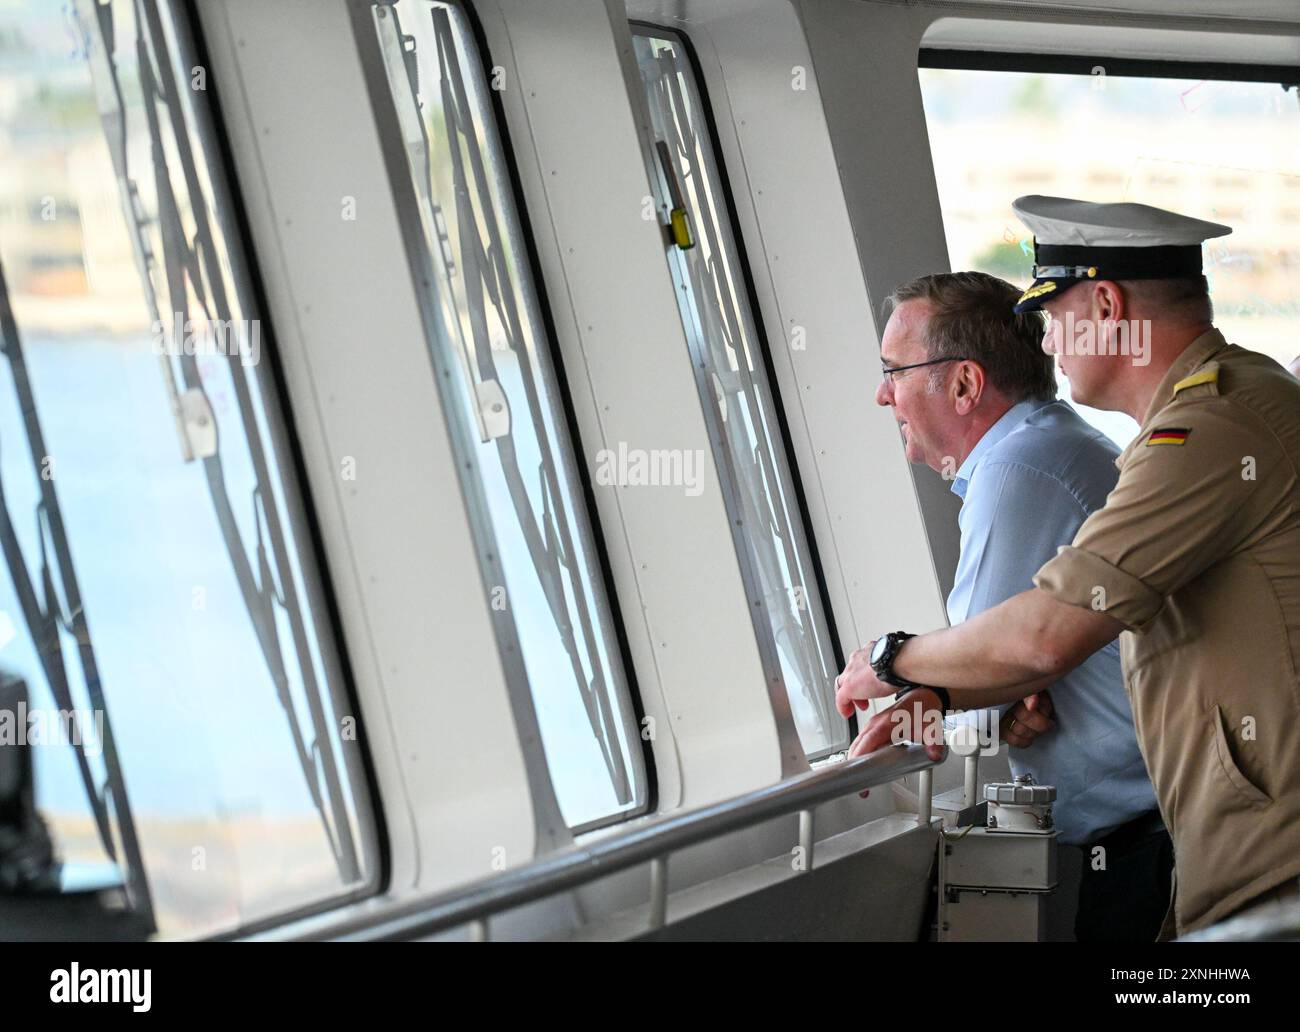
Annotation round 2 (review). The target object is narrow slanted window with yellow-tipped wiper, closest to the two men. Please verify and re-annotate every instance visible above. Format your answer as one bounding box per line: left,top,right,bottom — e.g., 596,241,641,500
632,25,849,759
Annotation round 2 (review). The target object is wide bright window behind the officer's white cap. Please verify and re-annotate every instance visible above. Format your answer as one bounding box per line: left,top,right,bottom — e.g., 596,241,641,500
920,60,1300,445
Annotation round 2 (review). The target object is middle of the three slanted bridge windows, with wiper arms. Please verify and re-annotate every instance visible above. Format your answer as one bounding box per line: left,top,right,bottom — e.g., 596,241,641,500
369,0,647,831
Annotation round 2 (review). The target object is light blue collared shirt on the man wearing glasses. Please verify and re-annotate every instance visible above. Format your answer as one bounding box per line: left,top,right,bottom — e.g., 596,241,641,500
948,400,1156,845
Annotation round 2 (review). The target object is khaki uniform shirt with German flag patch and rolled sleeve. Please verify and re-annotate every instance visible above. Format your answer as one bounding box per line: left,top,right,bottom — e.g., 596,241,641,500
1035,330,1300,933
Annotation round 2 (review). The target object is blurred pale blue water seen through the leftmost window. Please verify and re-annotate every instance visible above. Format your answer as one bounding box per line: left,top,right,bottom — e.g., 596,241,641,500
0,327,340,842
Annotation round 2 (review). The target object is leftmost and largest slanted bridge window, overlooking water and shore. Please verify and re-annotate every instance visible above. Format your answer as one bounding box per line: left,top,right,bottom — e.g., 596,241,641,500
0,0,378,938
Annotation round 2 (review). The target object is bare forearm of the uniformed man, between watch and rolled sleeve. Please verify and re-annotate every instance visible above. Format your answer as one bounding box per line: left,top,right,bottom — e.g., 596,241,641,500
894,587,1123,710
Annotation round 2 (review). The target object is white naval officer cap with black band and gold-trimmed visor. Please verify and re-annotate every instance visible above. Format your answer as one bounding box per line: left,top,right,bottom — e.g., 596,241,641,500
1011,194,1232,312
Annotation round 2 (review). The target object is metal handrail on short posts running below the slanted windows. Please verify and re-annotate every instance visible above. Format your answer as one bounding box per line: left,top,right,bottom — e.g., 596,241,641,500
270,743,935,941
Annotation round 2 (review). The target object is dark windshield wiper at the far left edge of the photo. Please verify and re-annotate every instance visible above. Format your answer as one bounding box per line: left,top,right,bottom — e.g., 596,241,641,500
0,253,155,928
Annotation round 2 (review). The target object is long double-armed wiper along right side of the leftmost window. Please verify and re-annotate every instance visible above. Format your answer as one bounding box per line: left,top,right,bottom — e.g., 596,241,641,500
77,0,360,883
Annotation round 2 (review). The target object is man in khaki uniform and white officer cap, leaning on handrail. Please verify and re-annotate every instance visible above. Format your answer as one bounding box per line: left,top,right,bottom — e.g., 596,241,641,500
837,198,1300,935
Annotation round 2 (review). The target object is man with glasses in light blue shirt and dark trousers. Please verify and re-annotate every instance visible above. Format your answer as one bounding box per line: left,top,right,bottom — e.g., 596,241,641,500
876,273,1173,941
